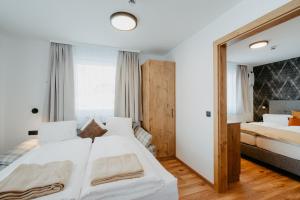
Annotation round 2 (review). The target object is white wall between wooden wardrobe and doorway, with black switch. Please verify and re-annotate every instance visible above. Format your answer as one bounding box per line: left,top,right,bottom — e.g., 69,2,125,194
168,0,288,182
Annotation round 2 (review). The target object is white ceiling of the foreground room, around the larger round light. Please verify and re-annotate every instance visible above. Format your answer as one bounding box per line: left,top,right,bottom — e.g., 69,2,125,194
0,0,241,54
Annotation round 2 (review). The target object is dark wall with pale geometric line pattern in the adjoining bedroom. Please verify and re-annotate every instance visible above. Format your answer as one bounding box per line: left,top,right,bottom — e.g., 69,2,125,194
253,57,300,121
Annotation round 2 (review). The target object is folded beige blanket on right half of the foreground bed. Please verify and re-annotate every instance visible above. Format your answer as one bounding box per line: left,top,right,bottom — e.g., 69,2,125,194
91,154,144,186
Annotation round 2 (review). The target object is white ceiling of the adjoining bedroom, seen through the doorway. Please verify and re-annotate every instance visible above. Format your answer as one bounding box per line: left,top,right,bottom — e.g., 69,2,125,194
227,17,300,66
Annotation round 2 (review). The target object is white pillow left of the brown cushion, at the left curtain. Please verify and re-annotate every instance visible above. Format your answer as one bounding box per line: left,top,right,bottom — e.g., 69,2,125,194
38,121,77,144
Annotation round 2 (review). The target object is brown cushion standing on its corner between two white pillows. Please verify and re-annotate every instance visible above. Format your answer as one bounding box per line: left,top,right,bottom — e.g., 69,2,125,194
79,120,107,142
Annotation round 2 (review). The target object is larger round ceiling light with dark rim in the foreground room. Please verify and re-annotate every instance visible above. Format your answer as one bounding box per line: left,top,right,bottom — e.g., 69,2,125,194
110,12,137,31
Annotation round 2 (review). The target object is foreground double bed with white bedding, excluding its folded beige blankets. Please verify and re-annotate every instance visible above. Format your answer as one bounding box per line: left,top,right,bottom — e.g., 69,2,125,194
0,118,178,200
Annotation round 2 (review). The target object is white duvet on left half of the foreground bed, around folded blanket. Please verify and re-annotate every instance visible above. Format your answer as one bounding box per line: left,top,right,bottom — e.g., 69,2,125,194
0,138,91,200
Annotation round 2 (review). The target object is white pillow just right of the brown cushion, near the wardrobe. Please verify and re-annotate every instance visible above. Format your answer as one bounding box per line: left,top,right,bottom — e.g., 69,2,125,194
106,117,134,137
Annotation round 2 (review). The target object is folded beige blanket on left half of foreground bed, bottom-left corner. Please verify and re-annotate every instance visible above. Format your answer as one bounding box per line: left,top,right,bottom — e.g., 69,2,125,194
0,161,73,200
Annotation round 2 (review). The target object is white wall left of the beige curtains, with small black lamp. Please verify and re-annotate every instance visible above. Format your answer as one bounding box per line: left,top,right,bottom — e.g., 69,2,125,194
0,32,49,152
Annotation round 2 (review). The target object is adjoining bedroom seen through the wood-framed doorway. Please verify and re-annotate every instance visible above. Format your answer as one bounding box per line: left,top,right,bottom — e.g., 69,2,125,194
227,13,300,194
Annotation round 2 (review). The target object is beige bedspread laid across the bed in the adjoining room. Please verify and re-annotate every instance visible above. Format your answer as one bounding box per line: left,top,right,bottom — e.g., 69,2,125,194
241,123,300,145
